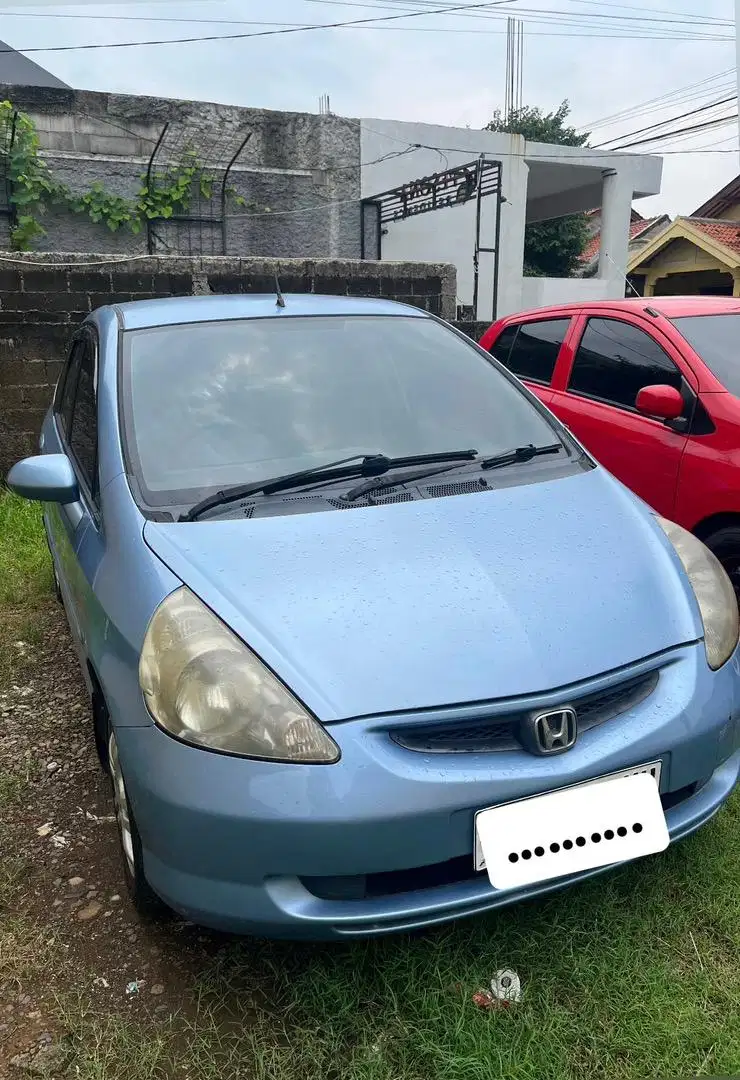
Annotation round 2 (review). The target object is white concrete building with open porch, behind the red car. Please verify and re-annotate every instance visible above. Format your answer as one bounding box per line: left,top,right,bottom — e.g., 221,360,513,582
360,120,661,321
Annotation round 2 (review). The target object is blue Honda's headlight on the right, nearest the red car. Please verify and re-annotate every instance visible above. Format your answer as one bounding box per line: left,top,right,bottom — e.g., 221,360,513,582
657,517,740,671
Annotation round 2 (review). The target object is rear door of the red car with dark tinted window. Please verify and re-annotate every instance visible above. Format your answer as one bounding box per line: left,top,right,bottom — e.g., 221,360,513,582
488,315,570,405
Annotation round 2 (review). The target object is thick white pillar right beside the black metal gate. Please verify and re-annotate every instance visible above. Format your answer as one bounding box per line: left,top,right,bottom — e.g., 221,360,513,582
492,135,529,319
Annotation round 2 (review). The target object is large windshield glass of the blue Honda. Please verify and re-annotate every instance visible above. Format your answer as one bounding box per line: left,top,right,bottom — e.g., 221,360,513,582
123,315,554,505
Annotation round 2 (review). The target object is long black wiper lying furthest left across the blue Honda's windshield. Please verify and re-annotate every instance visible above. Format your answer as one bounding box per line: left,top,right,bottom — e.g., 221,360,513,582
179,450,477,522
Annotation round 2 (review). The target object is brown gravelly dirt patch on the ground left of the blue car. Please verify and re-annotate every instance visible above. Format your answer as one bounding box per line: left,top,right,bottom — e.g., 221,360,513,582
0,604,231,1077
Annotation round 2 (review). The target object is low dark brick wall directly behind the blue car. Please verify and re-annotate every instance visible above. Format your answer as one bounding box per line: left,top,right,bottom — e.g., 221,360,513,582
0,255,456,477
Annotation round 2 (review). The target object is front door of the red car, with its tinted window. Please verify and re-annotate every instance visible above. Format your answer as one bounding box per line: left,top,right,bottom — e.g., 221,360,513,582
550,313,697,516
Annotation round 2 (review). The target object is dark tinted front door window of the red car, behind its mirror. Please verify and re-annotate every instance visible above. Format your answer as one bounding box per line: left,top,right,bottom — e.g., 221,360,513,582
568,319,683,408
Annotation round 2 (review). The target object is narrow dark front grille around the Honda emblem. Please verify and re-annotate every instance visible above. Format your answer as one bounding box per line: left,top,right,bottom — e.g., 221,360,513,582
391,672,659,754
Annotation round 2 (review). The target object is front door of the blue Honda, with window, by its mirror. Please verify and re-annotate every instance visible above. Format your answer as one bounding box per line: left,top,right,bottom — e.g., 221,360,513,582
45,327,103,663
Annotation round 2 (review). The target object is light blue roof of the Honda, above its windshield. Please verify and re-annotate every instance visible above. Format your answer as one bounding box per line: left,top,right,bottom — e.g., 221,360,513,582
105,293,429,330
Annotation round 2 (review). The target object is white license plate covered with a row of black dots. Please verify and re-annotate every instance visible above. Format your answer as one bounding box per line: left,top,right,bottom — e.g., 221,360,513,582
475,761,670,889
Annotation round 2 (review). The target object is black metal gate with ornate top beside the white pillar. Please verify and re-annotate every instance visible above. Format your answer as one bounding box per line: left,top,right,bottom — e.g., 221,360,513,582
360,153,504,319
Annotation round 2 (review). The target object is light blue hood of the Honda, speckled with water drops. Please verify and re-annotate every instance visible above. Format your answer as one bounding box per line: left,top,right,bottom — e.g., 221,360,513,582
145,469,702,721
